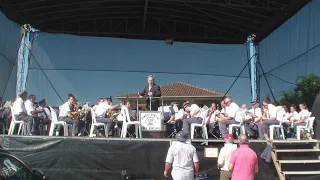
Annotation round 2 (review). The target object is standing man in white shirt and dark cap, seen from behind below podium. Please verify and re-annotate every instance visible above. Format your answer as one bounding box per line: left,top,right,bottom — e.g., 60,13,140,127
163,131,199,180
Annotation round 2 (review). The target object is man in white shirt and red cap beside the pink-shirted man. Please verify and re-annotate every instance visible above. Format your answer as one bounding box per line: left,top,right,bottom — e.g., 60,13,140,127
218,134,238,180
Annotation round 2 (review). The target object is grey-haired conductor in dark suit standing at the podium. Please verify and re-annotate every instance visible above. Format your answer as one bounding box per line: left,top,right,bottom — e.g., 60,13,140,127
139,75,161,111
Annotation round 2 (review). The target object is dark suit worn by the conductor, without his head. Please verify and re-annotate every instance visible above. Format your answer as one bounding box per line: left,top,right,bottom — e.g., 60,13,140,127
140,84,161,111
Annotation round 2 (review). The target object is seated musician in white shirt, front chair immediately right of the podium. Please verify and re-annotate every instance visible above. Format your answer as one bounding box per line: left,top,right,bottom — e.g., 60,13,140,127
183,102,203,134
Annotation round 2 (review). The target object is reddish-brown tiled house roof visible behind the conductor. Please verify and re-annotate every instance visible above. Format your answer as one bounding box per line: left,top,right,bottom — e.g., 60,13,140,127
117,82,224,98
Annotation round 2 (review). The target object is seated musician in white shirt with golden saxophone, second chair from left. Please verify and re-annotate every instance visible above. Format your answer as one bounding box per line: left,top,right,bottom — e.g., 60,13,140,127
58,94,79,136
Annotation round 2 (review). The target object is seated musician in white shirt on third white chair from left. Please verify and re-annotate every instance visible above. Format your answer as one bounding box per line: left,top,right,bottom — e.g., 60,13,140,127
95,97,120,136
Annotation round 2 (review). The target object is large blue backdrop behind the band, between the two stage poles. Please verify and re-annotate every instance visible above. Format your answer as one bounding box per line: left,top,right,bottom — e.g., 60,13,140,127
27,33,251,104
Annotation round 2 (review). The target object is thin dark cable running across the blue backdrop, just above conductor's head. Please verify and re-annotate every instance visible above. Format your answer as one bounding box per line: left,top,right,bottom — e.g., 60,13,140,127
29,68,249,78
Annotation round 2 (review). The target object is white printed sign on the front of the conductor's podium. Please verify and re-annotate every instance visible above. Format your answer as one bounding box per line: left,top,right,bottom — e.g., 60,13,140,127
139,111,163,131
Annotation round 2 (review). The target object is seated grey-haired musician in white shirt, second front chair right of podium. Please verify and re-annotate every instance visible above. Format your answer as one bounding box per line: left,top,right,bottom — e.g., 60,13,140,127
218,97,240,138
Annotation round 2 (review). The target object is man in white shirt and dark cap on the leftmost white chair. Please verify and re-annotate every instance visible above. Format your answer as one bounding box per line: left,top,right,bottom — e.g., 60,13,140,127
12,91,33,135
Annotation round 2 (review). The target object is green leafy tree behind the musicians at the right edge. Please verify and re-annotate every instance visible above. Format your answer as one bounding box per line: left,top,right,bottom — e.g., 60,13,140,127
280,74,320,110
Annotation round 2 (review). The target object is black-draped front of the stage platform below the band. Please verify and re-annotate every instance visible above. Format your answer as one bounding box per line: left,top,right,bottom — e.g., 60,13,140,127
0,135,319,180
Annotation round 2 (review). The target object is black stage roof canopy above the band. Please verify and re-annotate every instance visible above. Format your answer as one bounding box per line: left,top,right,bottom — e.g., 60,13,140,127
0,0,311,44
